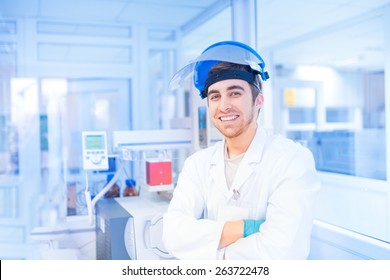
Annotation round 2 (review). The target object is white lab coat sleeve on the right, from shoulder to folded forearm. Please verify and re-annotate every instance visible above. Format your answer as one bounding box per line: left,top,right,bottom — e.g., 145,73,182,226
225,145,320,260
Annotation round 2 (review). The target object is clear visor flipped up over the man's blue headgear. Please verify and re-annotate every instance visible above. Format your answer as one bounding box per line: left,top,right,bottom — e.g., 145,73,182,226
169,44,265,90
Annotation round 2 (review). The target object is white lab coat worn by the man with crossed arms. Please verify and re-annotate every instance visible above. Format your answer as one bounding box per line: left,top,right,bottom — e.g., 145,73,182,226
163,127,320,260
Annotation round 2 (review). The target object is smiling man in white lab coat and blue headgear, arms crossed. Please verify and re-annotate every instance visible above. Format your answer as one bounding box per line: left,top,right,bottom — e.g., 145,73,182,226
163,41,319,259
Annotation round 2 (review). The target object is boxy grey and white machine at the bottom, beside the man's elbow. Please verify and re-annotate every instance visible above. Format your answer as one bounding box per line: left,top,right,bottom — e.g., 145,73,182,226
96,192,173,260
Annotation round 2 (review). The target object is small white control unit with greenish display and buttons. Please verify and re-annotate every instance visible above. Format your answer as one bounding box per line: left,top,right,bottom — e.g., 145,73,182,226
82,131,108,170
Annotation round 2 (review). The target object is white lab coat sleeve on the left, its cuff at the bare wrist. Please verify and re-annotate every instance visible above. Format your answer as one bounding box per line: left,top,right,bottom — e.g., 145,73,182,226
162,154,224,260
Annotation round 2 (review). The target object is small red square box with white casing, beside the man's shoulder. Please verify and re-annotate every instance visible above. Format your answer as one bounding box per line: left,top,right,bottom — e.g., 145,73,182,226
146,160,172,186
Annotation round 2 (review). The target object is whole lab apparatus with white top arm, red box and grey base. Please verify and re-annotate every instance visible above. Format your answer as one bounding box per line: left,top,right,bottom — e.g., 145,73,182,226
85,129,192,259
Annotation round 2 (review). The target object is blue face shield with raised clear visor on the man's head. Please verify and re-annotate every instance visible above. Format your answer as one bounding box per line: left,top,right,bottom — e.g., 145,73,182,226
169,41,269,98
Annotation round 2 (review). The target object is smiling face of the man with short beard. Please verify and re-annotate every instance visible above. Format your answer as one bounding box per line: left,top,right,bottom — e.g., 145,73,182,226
207,79,263,138
